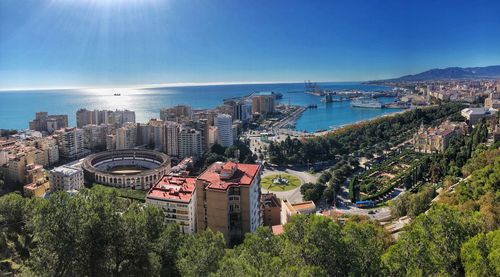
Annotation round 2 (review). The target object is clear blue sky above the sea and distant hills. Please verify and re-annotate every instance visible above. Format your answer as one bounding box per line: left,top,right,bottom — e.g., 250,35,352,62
0,0,500,88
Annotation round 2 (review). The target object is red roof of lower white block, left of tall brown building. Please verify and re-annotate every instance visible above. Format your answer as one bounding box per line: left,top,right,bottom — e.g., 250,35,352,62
146,175,196,202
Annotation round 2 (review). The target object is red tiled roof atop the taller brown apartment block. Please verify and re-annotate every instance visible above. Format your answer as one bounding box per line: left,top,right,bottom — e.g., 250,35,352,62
198,162,260,190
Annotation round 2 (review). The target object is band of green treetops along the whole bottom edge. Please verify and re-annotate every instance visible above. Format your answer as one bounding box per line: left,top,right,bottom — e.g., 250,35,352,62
0,182,499,276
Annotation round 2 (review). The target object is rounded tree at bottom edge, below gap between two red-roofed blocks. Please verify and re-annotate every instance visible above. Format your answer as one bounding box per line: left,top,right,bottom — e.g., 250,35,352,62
177,227,226,277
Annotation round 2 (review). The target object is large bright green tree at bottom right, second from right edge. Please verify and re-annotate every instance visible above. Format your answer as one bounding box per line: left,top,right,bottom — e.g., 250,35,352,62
382,206,482,276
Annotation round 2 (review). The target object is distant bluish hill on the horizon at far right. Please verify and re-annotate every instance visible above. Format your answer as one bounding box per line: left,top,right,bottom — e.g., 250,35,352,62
374,65,500,81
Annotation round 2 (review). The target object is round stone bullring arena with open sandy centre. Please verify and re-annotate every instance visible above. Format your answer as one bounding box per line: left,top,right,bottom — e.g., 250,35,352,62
82,149,170,190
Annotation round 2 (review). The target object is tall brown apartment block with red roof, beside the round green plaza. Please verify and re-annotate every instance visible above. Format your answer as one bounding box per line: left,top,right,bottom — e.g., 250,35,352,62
195,162,262,245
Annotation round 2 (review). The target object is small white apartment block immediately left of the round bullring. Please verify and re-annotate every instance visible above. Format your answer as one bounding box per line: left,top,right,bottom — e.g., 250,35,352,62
49,165,83,191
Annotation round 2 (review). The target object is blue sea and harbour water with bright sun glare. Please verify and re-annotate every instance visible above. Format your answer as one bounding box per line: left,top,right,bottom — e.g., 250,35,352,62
0,83,396,131
